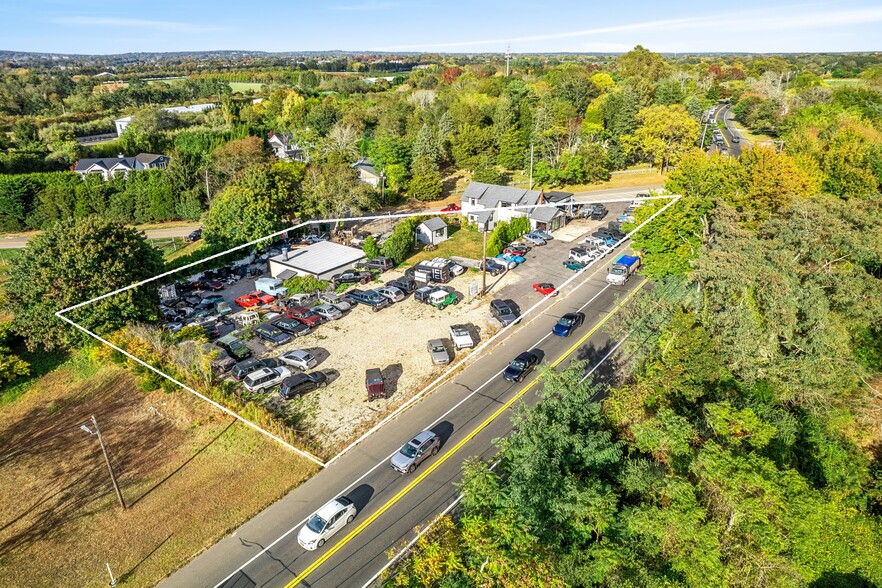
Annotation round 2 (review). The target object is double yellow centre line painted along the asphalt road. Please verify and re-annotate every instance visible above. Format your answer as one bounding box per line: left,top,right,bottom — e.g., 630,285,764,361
285,279,646,588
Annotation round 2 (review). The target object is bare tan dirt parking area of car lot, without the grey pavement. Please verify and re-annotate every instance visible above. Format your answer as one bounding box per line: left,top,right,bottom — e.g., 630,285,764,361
237,269,521,455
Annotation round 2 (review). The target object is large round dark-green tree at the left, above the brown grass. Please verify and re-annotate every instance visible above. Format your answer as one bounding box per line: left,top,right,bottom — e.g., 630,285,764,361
6,216,163,350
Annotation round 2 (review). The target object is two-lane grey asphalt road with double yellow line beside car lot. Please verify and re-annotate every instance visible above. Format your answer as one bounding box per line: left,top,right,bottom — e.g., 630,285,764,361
162,248,643,588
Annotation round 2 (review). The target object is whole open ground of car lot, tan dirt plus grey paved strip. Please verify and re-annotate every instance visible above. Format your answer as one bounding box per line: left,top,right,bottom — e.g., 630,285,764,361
158,203,626,454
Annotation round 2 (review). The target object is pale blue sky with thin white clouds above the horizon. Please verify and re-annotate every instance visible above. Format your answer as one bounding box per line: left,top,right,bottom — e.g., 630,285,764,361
0,0,882,54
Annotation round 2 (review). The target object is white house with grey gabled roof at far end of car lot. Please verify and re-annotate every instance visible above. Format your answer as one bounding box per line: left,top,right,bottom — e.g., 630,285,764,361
460,182,573,231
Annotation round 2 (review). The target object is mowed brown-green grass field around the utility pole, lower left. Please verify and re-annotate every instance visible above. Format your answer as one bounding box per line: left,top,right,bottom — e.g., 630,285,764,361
0,364,315,588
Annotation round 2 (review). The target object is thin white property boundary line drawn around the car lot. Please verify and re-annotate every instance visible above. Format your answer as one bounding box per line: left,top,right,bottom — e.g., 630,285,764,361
55,195,682,468
